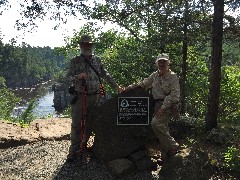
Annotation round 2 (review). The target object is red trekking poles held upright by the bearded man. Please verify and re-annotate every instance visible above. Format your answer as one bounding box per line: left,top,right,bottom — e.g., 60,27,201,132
80,79,87,162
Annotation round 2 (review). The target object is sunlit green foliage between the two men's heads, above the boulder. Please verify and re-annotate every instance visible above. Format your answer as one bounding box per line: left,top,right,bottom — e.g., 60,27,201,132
99,30,156,89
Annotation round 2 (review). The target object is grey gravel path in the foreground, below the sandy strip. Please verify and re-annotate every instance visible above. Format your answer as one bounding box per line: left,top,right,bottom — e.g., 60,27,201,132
0,140,159,180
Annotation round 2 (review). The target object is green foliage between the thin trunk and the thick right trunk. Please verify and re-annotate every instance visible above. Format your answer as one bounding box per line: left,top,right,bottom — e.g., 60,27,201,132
186,47,209,118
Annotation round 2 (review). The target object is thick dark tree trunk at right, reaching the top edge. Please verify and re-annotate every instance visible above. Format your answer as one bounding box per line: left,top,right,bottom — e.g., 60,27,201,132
205,0,224,131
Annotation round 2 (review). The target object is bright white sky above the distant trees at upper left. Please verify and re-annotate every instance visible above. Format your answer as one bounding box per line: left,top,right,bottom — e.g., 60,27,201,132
0,0,116,48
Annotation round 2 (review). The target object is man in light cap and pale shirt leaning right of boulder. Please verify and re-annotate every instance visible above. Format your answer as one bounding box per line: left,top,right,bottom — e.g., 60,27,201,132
125,53,180,163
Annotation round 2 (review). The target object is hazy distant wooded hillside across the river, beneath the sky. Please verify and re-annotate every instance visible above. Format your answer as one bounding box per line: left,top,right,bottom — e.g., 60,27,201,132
0,39,66,88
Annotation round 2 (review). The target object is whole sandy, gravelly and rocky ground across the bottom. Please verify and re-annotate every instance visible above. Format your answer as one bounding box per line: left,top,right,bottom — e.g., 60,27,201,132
0,118,240,180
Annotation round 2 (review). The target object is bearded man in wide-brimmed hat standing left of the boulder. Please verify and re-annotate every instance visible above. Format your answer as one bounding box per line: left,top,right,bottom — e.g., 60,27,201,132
66,35,122,162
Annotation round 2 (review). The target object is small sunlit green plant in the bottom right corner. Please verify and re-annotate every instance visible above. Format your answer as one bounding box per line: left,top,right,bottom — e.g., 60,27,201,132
224,146,240,171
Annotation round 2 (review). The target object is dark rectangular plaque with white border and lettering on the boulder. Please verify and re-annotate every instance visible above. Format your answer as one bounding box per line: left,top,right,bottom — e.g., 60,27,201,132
117,97,149,125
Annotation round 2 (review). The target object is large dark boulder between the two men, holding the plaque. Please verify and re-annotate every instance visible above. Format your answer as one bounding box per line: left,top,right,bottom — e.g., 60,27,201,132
93,88,156,162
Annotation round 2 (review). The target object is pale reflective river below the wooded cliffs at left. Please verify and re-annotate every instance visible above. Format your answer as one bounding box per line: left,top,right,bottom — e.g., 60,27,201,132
13,81,58,118
